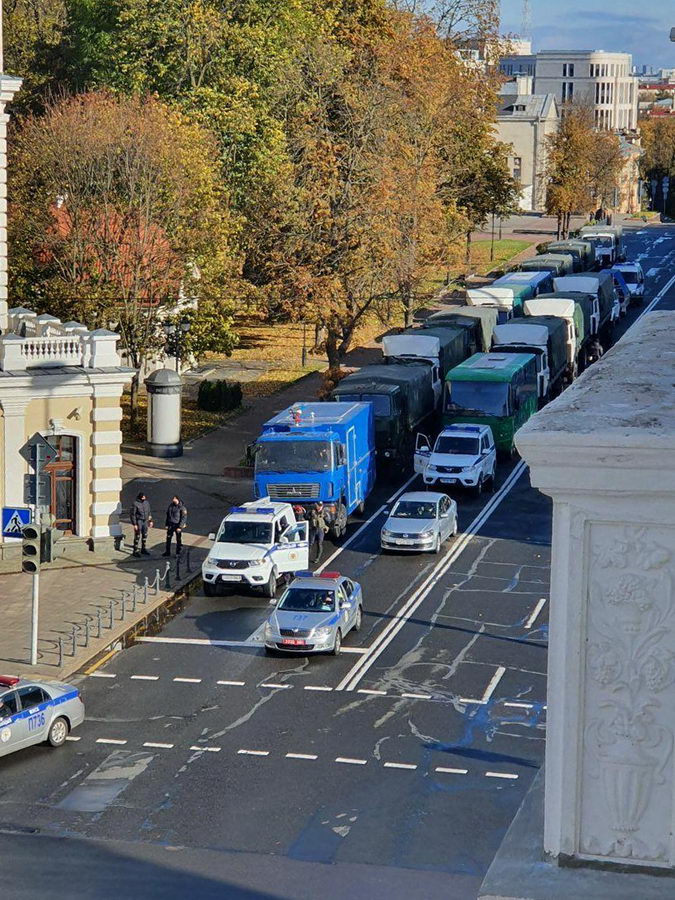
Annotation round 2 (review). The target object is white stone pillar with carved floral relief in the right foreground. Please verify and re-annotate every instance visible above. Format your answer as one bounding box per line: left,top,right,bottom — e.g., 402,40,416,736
516,312,675,872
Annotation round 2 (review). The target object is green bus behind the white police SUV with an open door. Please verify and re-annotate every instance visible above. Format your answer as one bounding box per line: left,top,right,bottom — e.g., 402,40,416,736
443,354,538,456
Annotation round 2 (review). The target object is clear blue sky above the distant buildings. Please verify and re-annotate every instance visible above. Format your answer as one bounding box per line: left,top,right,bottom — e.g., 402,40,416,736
501,0,675,68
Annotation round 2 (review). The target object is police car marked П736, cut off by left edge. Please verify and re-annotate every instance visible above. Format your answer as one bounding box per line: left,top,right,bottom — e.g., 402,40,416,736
0,675,84,756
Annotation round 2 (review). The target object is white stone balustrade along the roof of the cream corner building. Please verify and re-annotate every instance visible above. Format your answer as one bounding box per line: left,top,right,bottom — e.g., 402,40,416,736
0,307,122,372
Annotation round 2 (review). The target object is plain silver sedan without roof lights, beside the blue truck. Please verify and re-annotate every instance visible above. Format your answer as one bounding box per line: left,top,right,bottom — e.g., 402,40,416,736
380,491,457,553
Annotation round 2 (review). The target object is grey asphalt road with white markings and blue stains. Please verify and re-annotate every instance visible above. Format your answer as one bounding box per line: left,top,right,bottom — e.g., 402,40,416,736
0,226,675,900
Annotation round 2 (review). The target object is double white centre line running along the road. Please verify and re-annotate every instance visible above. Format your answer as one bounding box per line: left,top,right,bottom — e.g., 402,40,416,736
336,460,528,691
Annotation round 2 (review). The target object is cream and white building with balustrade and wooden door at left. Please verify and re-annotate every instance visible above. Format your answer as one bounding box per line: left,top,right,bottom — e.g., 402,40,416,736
0,54,133,569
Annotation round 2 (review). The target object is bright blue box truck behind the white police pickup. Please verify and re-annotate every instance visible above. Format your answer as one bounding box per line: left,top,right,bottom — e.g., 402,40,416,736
254,400,378,539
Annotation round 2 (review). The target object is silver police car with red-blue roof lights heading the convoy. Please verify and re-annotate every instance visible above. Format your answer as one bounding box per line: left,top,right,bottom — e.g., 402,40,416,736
264,572,363,656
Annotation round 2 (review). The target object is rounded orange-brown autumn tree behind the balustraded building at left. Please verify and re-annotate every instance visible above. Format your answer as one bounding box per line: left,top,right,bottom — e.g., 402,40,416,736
9,92,236,420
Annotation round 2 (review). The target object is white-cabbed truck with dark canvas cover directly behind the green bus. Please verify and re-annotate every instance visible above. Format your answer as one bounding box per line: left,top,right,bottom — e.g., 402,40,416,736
492,316,567,406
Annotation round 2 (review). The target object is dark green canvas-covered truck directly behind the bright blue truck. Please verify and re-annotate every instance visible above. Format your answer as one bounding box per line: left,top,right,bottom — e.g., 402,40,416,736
332,362,437,475
